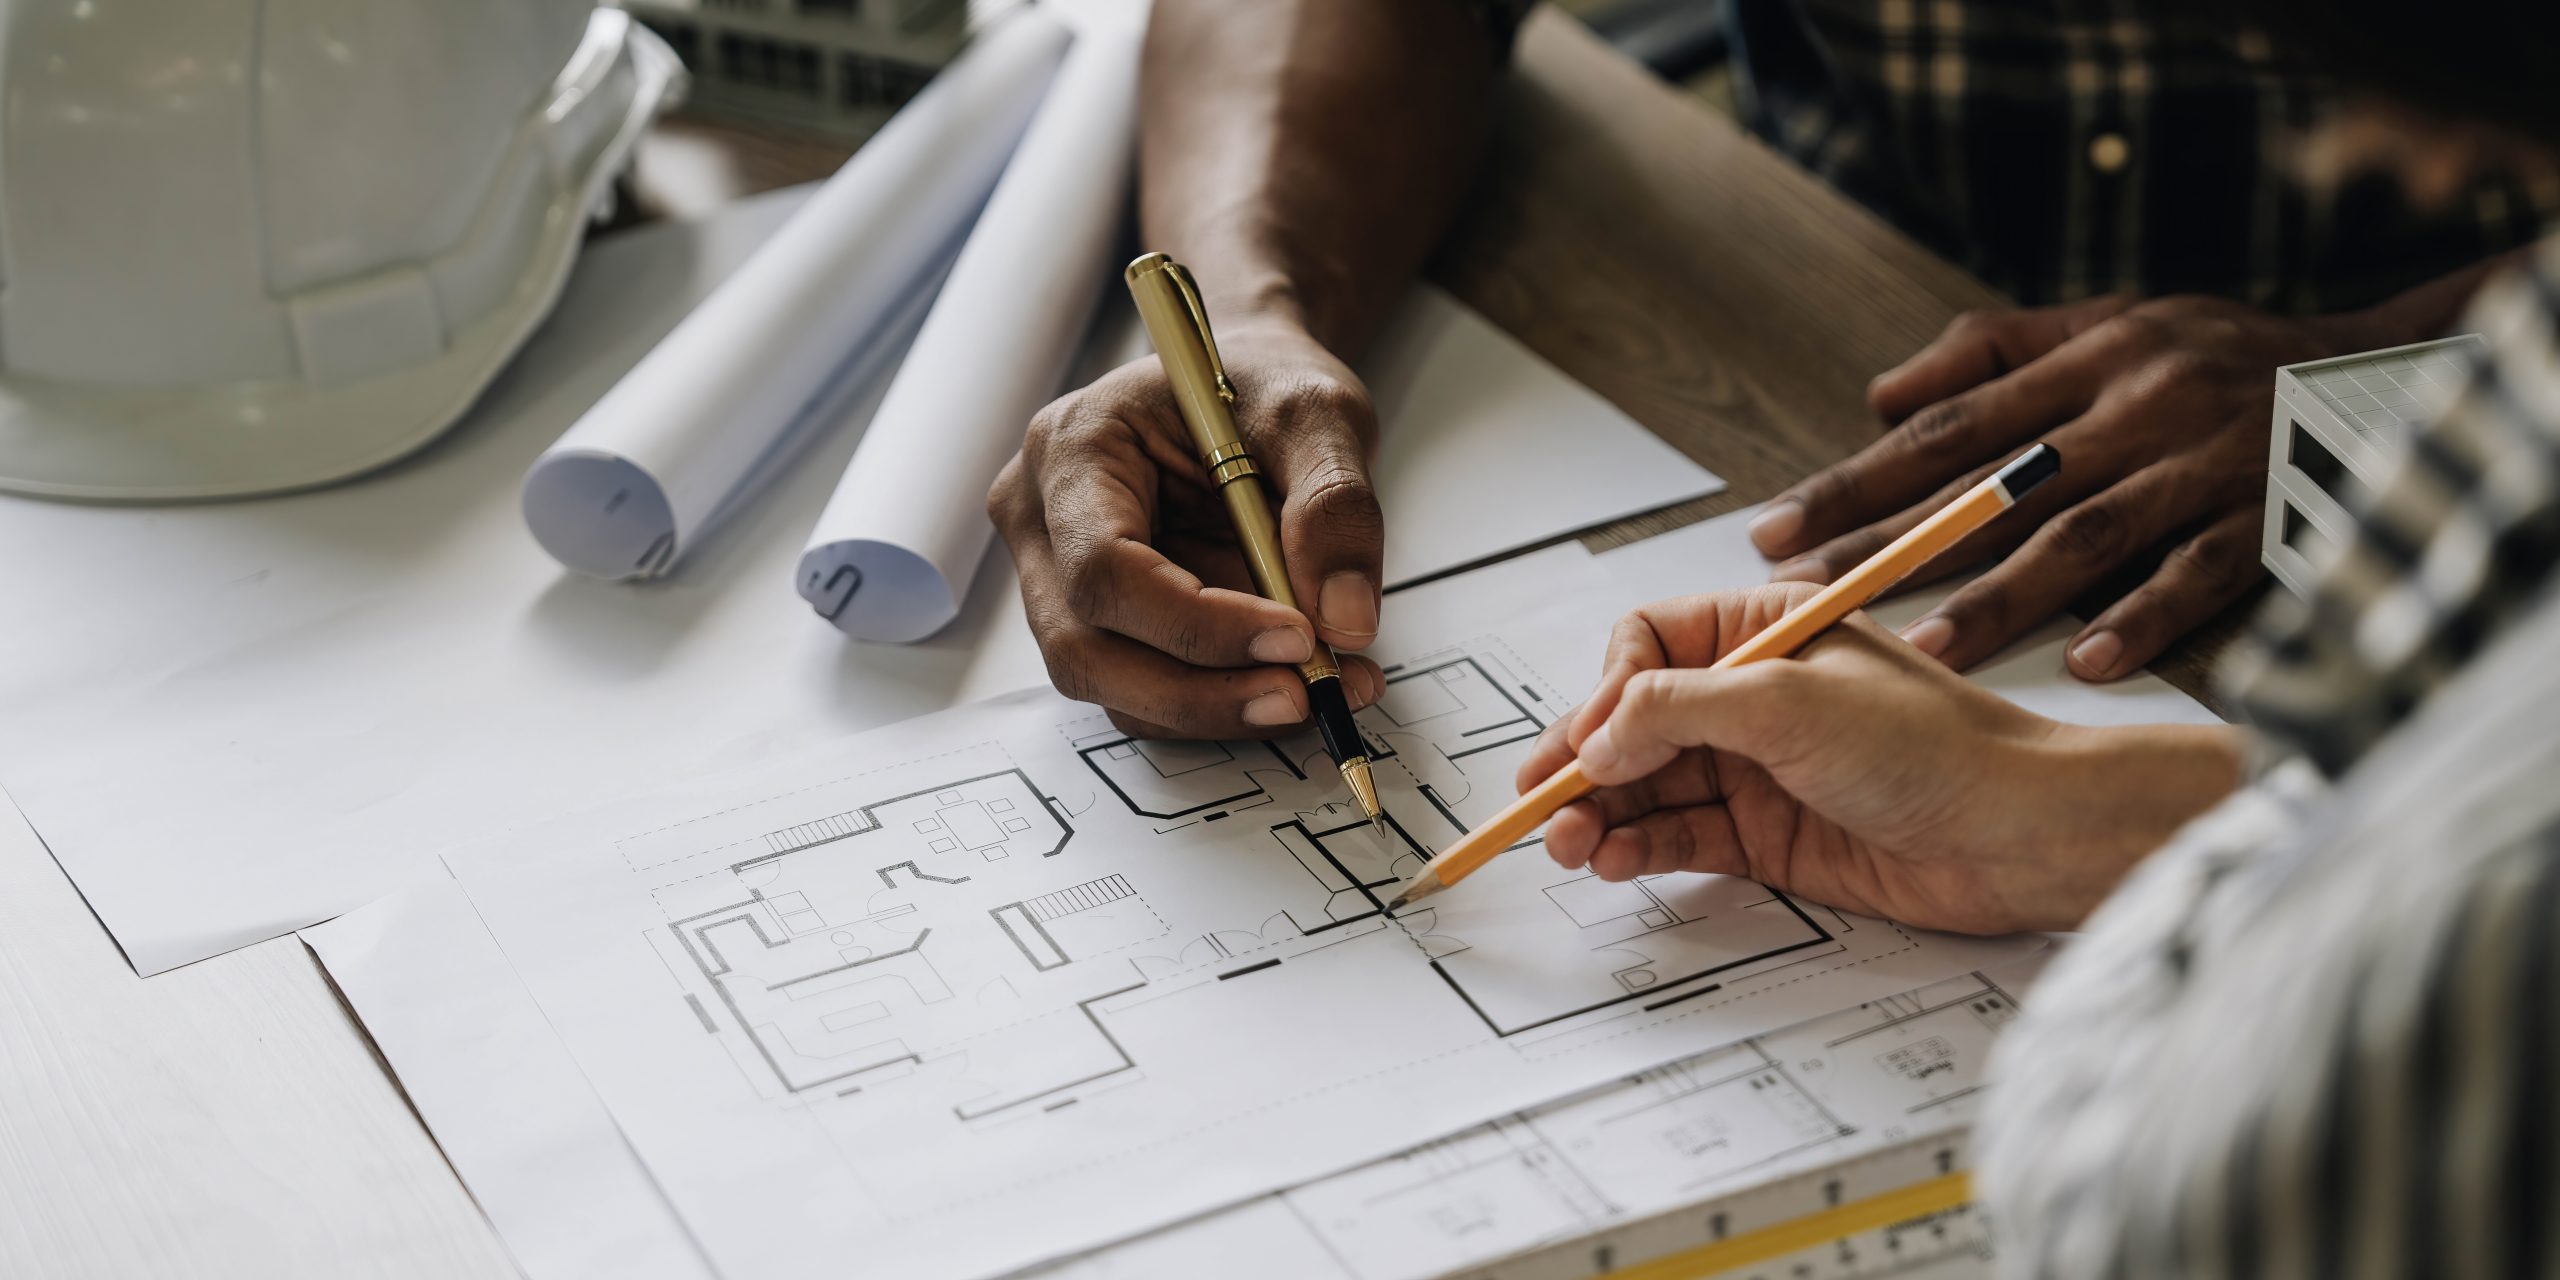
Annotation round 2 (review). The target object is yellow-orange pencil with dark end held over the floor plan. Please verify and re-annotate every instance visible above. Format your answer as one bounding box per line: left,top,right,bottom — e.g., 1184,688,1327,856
1388,445,2063,911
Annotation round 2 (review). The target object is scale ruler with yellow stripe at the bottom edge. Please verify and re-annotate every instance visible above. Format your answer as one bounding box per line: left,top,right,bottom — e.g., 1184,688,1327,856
1469,1132,1992,1280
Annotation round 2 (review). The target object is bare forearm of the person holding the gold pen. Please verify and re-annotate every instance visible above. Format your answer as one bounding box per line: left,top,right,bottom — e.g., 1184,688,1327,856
1139,0,1495,356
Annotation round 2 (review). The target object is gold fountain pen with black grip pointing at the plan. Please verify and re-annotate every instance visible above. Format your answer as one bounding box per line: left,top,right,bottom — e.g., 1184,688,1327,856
1124,253,1380,822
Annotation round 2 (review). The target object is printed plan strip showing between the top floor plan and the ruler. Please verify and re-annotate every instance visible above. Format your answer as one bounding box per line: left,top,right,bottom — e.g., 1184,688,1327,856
1003,957,2040,1280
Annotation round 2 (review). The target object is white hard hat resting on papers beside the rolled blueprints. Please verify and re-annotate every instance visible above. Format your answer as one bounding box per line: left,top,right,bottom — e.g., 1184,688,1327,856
0,0,684,499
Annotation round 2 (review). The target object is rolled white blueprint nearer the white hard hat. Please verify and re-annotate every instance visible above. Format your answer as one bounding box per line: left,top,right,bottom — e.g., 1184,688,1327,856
522,8,1070,579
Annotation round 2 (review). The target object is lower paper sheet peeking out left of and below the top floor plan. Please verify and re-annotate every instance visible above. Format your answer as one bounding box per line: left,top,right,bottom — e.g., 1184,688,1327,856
305,883,2051,1280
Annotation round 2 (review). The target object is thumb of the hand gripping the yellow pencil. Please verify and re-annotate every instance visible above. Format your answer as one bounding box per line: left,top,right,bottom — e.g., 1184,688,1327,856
1577,660,1802,786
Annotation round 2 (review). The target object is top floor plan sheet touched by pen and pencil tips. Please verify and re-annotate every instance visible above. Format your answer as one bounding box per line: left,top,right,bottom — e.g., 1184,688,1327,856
456,601,2025,1275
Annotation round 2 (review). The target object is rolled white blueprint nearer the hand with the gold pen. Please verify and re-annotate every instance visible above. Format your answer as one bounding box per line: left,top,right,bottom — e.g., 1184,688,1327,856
799,26,1137,643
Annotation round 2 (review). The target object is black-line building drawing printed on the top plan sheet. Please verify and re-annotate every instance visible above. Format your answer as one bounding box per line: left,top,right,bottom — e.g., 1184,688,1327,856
655,640,1910,1121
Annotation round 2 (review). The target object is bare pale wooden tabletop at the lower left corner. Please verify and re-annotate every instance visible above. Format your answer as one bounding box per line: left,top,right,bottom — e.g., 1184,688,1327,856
0,804,517,1280
